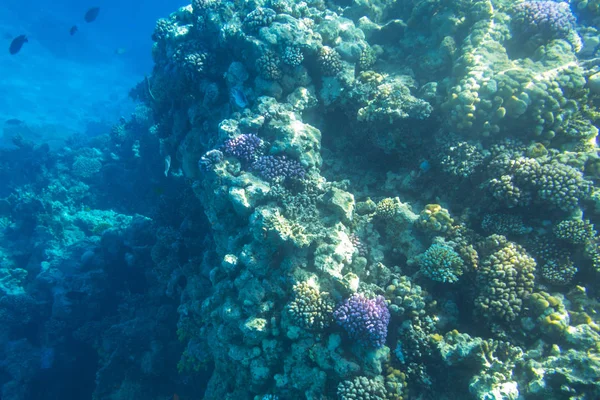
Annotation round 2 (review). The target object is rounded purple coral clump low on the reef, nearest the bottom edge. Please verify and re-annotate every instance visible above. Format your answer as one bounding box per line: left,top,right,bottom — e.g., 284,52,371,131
333,293,390,348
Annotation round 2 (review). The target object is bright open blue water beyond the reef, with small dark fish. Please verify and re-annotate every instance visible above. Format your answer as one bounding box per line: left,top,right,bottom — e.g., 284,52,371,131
0,0,185,137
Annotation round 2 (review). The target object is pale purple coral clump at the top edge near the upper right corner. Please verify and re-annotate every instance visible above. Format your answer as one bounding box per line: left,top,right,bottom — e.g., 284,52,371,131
512,0,575,39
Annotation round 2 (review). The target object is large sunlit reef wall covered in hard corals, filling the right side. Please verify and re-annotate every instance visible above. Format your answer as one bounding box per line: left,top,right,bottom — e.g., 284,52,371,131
141,0,600,400
